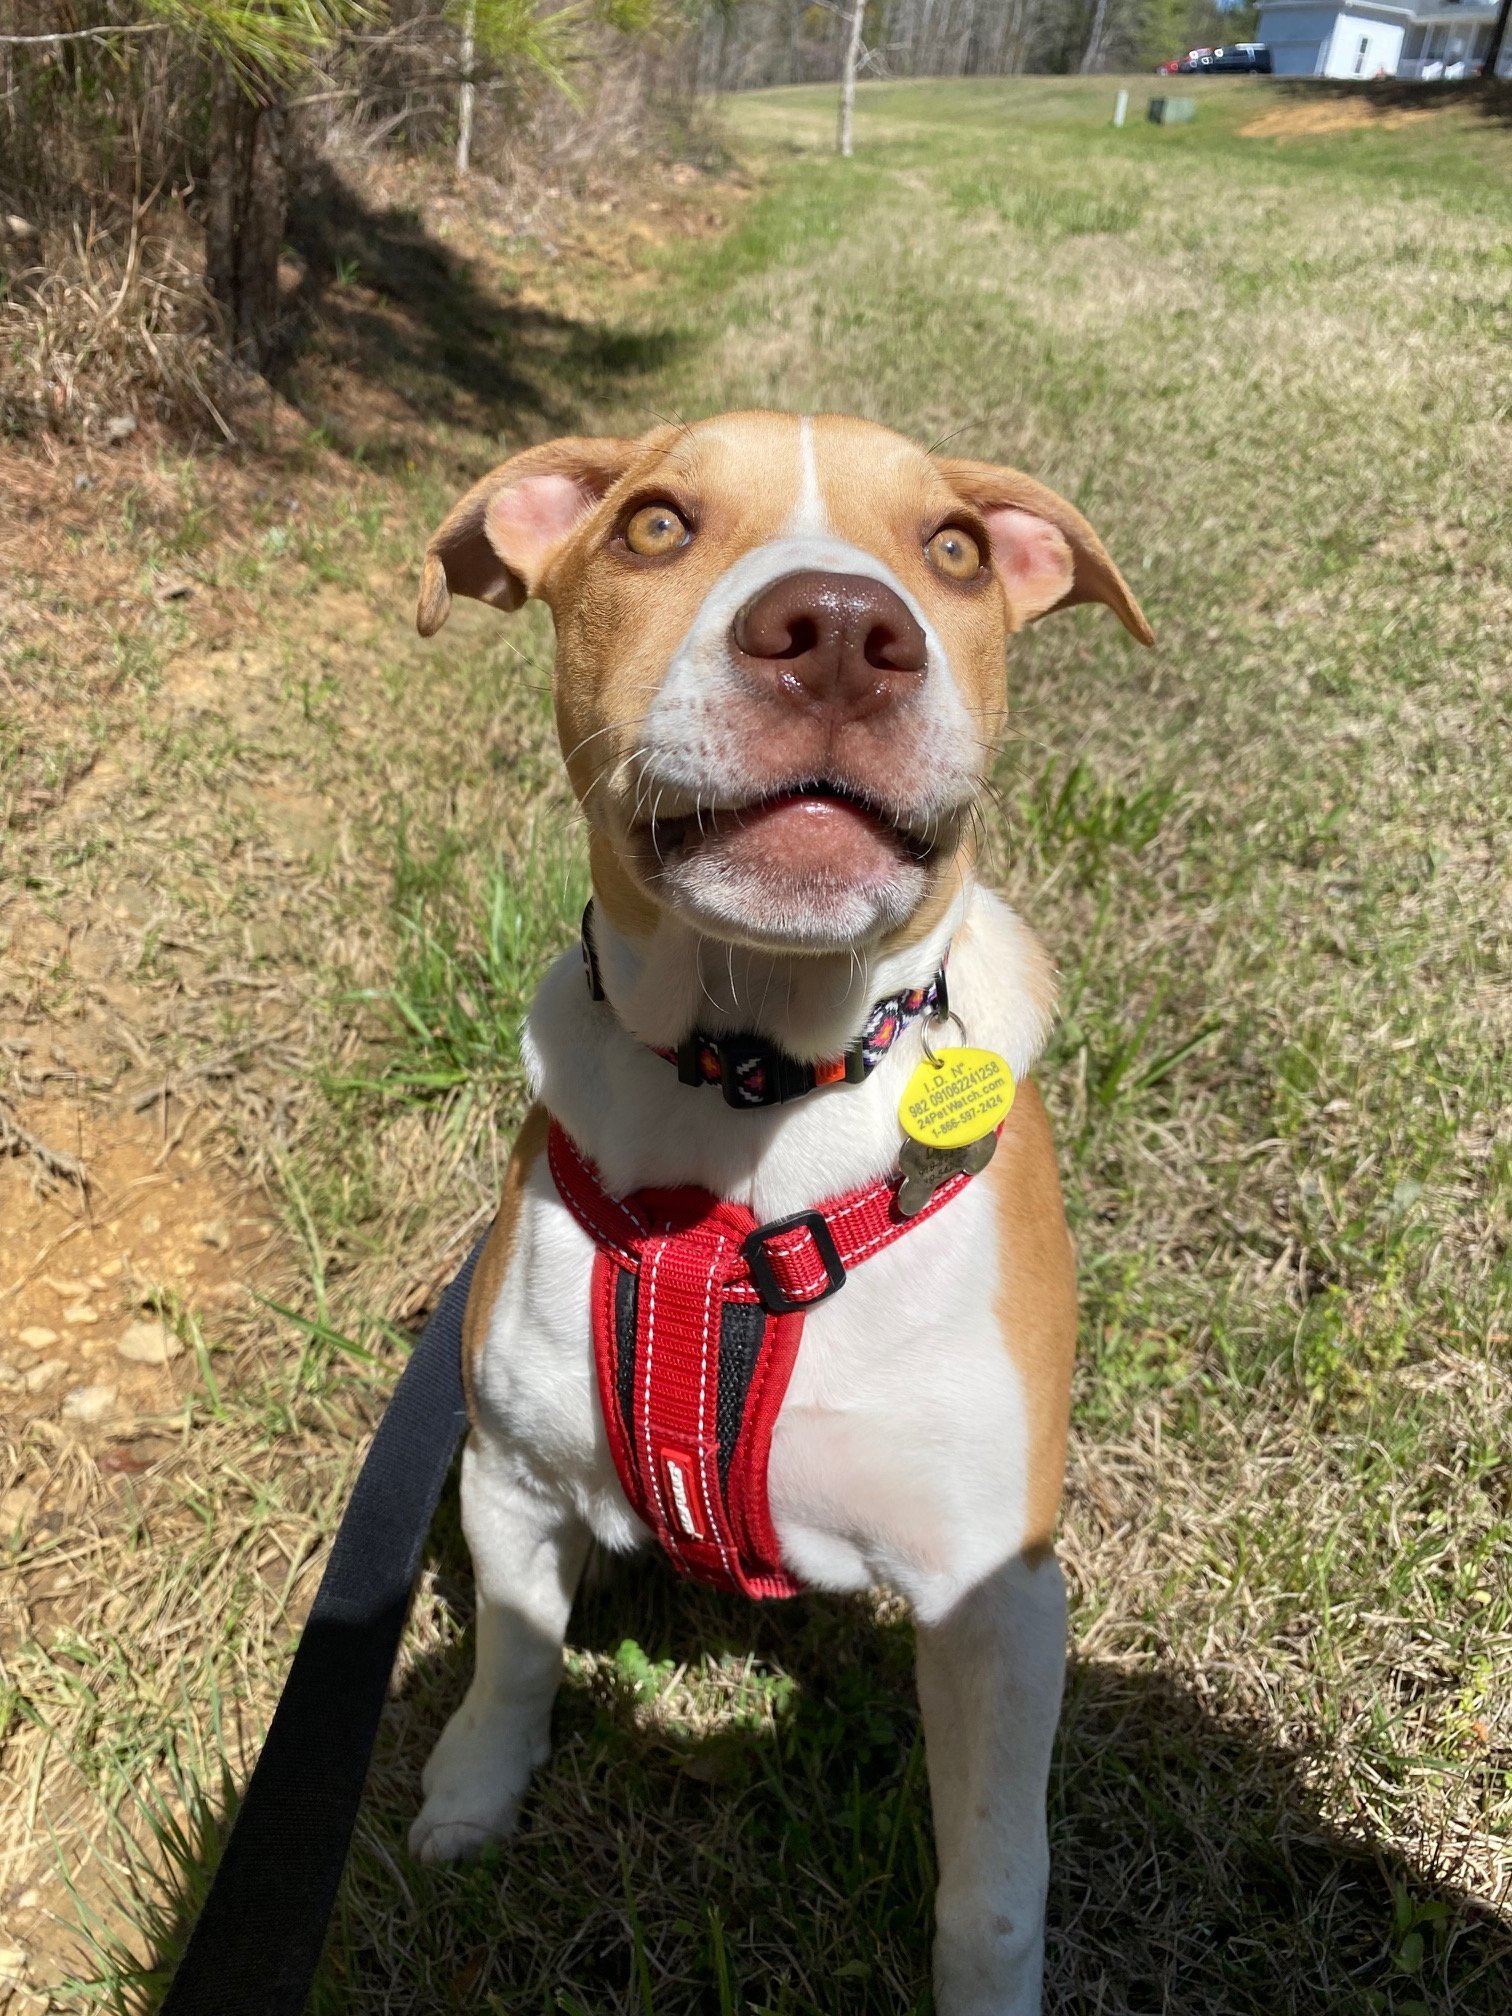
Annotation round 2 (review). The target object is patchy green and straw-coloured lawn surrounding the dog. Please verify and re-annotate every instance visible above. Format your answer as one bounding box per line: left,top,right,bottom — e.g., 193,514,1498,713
8,81,1512,2016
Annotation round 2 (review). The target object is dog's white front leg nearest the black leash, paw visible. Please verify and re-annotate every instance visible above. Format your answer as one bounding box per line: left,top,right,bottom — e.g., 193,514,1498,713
409,1431,589,1863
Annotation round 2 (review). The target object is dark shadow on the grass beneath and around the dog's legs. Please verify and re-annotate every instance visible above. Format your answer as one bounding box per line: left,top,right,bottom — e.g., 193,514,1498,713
113,1524,1512,2016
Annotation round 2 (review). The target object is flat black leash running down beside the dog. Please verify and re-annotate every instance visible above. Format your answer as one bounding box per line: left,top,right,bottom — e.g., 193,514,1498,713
159,1240,482,2016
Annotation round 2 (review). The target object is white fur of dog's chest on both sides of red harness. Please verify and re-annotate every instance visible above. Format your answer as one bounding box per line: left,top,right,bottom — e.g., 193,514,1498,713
478,1165,1026,1615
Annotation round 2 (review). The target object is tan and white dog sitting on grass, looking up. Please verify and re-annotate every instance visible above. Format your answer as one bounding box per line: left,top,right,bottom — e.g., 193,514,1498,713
411,413,1151,2016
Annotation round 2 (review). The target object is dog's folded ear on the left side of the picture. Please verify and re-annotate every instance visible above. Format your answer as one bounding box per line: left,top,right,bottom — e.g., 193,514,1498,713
415,435,641,637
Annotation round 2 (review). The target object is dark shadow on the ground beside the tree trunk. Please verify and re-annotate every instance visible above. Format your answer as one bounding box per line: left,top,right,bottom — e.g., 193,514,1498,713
270,161,694,468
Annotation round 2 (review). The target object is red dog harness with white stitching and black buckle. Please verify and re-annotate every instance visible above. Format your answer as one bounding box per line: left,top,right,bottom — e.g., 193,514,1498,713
546,1121,970,1597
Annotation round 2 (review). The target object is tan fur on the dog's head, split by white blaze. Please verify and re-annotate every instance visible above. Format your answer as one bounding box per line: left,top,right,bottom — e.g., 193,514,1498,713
417,411,1153,959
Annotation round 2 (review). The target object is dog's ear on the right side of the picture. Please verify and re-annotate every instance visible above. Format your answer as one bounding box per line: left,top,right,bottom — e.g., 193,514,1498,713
935,456,1155,643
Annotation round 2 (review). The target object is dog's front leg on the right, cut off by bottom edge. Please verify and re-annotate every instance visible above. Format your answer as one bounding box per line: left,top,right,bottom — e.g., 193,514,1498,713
919,1556,1066,2016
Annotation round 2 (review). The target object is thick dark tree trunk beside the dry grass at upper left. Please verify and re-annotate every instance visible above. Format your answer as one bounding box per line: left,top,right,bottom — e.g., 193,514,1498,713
206,62,288,369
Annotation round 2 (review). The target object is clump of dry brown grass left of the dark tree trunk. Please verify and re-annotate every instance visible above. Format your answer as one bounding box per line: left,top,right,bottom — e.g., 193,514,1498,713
0,222,246,442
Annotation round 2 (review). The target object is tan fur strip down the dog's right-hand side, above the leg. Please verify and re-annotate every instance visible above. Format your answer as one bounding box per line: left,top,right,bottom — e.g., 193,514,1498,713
980,1081,1077,1562
